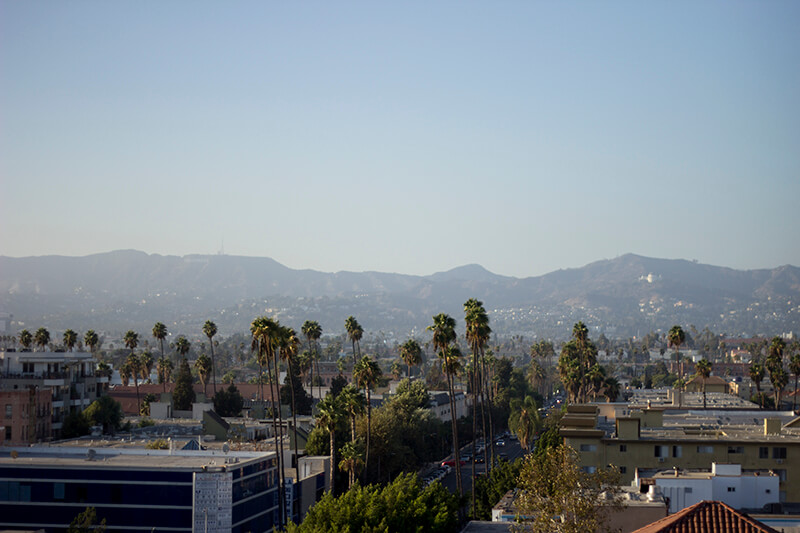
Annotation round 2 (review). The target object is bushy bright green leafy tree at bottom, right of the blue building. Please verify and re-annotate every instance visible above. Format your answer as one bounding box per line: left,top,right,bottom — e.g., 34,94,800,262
288,474,458,533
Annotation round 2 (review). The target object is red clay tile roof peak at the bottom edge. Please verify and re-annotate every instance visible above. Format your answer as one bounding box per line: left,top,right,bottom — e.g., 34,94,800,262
633,500,778,533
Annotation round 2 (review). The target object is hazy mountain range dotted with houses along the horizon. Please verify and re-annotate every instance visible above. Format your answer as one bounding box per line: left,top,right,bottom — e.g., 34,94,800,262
0,250,800,336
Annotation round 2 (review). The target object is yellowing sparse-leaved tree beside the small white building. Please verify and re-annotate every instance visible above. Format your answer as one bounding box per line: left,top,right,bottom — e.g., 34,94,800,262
516,445,622,533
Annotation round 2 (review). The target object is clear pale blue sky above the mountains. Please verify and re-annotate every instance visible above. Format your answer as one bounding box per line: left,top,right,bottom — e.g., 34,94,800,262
0,0,800,277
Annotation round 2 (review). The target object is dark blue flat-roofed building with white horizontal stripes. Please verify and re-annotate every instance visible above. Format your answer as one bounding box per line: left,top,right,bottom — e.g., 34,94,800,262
0,447,278,533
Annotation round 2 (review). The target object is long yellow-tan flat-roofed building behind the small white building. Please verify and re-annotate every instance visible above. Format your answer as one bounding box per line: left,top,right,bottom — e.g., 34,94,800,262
560,405,800,502
